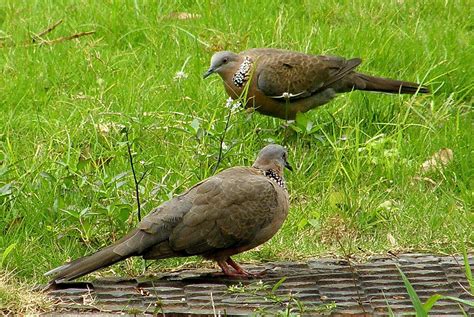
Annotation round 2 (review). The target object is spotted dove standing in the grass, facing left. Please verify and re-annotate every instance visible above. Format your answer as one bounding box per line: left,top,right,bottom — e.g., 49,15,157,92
204,48,429,119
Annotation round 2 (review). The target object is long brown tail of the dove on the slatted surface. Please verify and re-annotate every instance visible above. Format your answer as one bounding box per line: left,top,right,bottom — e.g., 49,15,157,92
44,245,131,283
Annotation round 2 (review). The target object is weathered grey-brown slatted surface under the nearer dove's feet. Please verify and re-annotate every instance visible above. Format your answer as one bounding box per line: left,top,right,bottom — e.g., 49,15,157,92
49,254,474,316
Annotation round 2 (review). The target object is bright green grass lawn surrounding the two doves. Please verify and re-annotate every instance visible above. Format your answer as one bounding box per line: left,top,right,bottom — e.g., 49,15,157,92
0,0,474,282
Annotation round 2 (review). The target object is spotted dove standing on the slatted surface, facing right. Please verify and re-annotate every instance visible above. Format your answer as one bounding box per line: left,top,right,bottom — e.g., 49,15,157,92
45,144,292,284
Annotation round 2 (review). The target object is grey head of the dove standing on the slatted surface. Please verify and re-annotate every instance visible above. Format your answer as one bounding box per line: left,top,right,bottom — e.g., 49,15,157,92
252,144,293,175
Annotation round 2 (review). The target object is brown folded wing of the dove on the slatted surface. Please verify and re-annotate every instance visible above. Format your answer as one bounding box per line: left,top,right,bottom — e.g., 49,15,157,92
170,168,278,254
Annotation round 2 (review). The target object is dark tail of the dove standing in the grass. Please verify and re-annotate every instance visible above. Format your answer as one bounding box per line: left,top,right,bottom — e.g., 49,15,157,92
354,73,430,95
